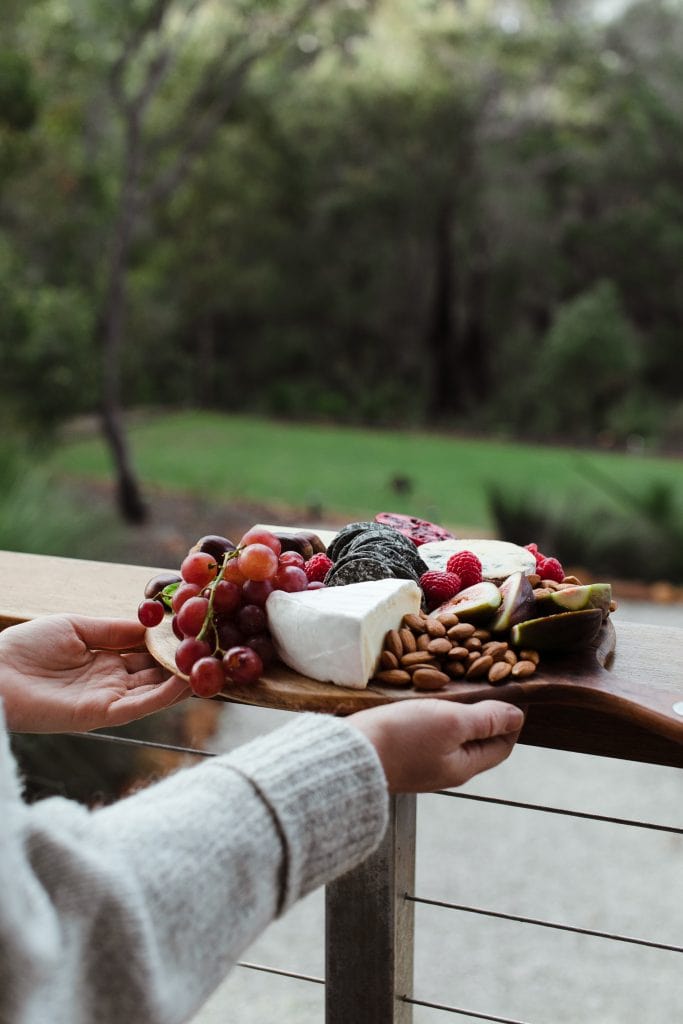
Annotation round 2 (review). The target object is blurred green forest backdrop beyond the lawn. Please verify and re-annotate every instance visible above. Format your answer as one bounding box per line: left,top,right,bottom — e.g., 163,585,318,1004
0,0,683,450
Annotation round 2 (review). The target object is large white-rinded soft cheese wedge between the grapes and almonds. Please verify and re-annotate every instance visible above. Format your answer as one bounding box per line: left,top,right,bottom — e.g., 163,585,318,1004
265,580,422,689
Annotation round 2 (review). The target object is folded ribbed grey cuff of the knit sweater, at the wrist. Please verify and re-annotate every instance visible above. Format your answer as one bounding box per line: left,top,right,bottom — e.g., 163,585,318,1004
220,714,388,911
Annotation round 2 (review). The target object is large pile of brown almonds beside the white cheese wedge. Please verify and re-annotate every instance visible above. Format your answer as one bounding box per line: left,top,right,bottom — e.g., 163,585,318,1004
373,611,539,690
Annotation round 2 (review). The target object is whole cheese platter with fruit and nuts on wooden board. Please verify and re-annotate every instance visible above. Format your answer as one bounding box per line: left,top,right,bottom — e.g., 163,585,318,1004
138,517,683,743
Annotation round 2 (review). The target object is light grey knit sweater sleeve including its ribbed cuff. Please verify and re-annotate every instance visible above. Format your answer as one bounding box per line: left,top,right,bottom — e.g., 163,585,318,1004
0,708,387,1024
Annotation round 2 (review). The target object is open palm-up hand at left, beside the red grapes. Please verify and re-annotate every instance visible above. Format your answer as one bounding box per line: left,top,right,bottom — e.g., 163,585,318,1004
0,615,189,732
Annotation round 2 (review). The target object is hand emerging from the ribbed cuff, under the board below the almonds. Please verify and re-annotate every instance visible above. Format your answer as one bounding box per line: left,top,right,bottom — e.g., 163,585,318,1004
348,698,524,793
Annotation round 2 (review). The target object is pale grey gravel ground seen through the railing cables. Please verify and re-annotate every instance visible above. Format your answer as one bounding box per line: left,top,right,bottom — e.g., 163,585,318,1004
194,601,683,1024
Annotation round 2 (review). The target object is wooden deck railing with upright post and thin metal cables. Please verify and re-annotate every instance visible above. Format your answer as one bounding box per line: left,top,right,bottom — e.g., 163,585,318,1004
0,552,683,1024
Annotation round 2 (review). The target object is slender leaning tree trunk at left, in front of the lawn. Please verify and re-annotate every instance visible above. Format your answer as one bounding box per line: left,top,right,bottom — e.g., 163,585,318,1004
99,128,147,523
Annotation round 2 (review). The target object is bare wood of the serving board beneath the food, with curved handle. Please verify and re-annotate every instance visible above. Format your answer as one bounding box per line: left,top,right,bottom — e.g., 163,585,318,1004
146,618,683,743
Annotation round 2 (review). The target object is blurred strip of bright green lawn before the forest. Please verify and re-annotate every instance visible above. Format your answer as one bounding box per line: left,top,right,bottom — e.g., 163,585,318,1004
54,412,683,530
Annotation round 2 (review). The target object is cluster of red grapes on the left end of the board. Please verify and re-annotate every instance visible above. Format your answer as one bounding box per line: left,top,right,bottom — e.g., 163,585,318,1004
137,526,324,697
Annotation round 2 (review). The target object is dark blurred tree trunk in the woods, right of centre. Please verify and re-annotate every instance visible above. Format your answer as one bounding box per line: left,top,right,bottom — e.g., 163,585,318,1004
426,199,458,420
